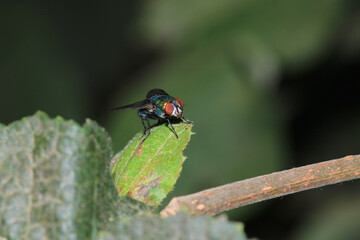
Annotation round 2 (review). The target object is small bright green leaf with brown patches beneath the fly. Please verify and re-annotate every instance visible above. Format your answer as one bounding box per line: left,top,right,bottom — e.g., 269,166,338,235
111,123,192,206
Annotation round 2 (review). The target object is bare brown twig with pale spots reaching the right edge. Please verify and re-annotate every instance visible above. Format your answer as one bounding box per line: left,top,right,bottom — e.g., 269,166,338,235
161,155,360,217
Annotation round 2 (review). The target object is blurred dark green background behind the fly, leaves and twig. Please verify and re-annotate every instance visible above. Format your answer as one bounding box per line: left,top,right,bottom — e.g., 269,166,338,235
0,0,360,240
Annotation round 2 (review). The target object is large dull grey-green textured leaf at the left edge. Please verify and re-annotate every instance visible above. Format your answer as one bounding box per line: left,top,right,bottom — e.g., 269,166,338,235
0,112,117,239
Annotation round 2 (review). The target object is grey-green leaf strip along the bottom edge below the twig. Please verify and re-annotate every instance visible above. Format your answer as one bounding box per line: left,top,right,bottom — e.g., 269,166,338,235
97,213,247,240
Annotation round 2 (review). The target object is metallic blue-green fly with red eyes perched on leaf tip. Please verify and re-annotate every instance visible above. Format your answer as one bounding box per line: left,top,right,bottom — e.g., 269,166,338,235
112,89,191,141
